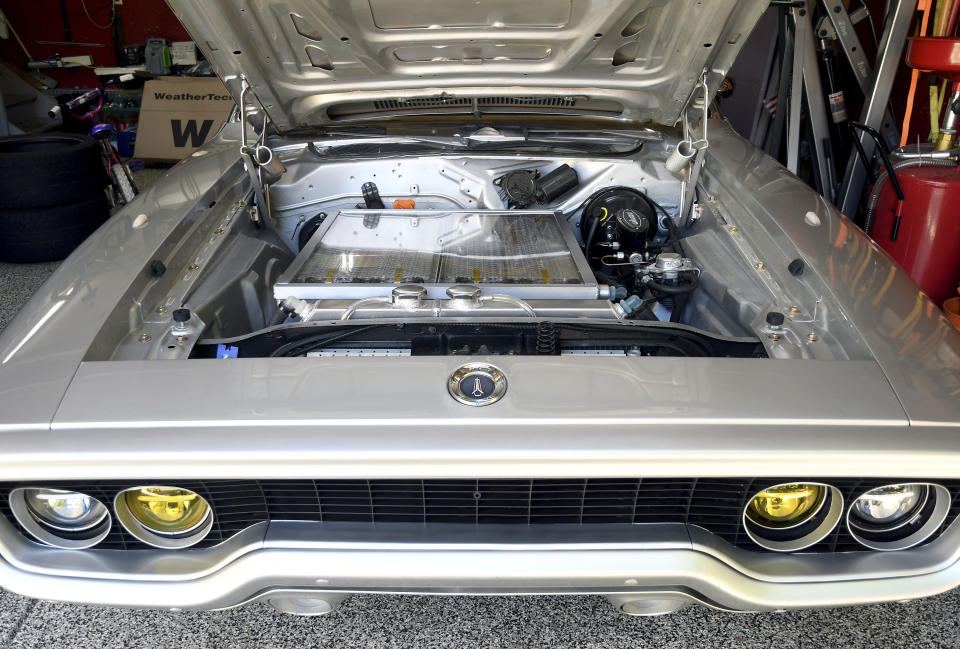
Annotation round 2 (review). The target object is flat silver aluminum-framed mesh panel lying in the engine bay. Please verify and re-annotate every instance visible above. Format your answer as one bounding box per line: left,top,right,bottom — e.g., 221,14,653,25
275,210,596,299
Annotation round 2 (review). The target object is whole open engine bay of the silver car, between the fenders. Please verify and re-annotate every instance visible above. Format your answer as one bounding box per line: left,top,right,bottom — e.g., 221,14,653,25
95,138,832,359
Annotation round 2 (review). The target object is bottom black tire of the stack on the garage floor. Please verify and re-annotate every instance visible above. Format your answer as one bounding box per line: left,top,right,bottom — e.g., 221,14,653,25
0,190,110,263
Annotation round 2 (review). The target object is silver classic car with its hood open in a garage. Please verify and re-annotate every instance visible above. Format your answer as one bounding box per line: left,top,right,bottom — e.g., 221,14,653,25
0,0,960,615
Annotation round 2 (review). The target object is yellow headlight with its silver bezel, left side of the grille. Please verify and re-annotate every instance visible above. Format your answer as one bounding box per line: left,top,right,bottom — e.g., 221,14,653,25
114,486,213,548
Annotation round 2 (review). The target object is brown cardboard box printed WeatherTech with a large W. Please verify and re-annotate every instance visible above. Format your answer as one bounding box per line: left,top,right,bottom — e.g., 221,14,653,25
135,77,234,161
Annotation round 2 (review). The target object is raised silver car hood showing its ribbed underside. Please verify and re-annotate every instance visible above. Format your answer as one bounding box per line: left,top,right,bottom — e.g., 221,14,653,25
168,0,769,131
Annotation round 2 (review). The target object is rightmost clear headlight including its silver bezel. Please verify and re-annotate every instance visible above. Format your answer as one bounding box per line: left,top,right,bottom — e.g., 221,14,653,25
847,482,950,550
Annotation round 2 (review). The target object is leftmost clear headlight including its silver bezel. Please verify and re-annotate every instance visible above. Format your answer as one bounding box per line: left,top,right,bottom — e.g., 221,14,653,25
10,487,110,550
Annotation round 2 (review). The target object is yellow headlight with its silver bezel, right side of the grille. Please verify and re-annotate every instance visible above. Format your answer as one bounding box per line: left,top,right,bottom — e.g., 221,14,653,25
743,482,843,552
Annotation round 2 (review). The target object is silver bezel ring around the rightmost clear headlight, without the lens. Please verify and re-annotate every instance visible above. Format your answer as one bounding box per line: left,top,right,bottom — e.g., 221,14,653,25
845,482,951,552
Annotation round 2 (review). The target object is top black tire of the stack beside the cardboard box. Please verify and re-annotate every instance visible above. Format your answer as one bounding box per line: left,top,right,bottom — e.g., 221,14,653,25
0,133,107,209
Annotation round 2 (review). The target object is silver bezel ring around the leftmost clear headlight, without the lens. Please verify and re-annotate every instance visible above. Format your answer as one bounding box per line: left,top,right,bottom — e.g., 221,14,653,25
8,487,113,550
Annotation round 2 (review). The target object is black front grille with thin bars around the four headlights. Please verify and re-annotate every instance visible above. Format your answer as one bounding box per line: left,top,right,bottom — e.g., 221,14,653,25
0,478,960,552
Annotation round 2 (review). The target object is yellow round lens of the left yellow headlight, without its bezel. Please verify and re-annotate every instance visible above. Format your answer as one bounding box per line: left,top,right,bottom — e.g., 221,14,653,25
123,487,210,536
